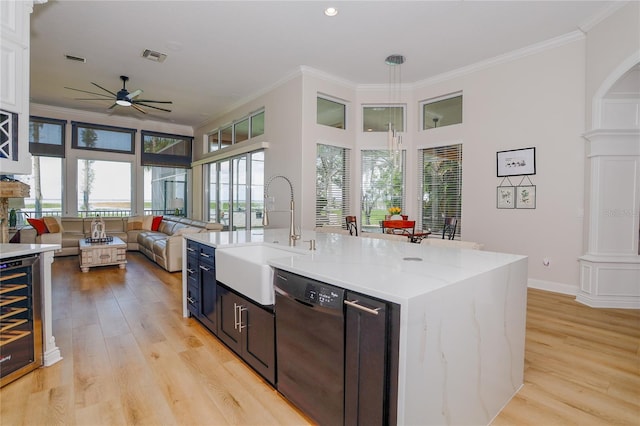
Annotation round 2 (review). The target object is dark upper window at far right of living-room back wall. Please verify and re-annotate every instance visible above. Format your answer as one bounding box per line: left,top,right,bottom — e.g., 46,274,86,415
141,130,193,168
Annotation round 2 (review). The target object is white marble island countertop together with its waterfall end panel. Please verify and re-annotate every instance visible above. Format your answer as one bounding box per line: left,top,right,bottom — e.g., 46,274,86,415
183,229,527,425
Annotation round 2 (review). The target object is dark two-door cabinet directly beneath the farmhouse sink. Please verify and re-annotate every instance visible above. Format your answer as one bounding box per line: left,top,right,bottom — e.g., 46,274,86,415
217,284,276,384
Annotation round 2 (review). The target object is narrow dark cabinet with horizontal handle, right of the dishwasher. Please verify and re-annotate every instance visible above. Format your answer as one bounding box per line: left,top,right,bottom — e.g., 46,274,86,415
344,292,400,425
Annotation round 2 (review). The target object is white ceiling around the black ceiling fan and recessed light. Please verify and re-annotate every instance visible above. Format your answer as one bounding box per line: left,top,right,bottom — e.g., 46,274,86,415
31,0,619,126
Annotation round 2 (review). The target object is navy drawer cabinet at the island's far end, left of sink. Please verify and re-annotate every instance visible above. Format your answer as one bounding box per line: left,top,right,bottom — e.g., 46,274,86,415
186,240,218,334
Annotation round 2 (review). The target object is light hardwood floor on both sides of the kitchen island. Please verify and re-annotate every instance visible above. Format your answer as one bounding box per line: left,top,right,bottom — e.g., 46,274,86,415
0,253,640,426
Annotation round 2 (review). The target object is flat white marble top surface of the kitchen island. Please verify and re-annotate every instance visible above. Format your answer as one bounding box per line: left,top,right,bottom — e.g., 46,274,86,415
185,229,525,304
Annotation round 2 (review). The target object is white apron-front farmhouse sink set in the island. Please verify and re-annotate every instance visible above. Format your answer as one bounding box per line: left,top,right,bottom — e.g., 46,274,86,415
216,244,304,305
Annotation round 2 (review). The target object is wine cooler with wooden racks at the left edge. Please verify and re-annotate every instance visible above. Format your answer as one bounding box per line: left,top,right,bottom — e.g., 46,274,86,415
0,256,42,386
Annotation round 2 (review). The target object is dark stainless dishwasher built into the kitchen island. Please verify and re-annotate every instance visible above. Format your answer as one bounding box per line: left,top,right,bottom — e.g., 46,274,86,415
274,269,344,425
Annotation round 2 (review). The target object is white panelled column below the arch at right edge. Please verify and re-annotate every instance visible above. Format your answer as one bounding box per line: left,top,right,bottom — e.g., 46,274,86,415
576,130,640,309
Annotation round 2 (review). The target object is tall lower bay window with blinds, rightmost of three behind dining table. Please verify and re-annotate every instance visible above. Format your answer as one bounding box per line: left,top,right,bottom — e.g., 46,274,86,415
418,144,462,237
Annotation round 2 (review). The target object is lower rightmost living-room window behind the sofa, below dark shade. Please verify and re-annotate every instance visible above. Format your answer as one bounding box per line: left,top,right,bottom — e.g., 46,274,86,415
144,167,188,216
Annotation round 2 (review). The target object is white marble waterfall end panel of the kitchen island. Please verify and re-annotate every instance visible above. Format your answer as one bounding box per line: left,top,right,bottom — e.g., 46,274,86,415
398,258,527,425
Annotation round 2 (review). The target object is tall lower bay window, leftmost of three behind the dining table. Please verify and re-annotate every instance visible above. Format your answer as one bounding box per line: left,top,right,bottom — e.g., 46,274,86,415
316,144,351,226
